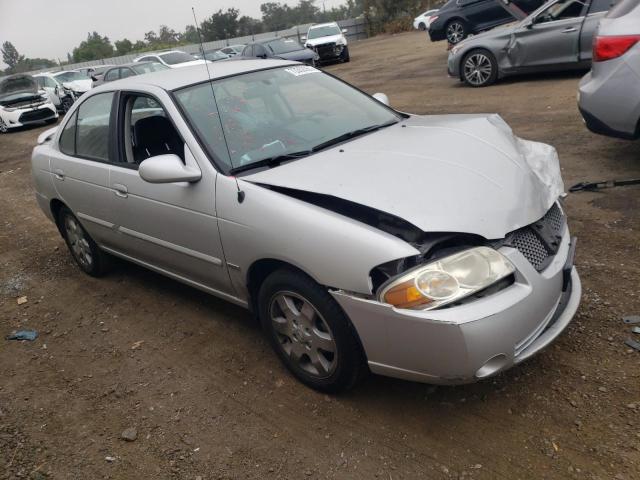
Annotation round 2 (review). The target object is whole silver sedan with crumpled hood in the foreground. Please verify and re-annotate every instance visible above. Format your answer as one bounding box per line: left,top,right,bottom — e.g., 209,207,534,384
32,60,581,392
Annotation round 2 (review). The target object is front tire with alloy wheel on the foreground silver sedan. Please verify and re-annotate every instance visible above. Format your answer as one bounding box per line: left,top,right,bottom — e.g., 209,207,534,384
258,269,366,393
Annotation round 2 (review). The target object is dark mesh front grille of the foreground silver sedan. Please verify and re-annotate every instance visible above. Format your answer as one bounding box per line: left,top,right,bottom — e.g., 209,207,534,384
506,203,565,272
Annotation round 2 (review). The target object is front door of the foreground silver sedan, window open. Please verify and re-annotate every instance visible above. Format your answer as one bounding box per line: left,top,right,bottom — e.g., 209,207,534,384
109,93,232,294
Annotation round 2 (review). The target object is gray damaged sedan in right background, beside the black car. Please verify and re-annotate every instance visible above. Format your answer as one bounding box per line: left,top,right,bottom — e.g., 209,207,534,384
448,0,613,87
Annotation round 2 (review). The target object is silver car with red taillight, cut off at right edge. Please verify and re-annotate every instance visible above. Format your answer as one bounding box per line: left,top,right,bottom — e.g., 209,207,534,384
578,0,640,139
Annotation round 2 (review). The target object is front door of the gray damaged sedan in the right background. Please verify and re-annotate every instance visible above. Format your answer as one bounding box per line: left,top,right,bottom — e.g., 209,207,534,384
509,0,586,70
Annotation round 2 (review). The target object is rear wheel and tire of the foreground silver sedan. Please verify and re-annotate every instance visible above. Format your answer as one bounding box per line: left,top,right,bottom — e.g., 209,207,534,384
58,207,109,277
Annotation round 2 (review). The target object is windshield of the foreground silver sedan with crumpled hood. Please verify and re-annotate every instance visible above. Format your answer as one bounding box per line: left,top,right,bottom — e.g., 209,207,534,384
175,66,400,173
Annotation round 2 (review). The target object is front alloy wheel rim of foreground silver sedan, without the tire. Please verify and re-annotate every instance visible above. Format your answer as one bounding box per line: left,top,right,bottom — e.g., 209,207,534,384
269,292,338,378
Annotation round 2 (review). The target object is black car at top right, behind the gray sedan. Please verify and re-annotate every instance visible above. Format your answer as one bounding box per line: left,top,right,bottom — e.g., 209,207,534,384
429,0,545,45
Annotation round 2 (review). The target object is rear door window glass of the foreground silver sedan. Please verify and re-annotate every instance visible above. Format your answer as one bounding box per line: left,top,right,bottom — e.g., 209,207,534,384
76,92,113,162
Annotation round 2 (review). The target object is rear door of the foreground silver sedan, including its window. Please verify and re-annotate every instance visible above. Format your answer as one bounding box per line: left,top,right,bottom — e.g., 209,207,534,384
50,92,115,246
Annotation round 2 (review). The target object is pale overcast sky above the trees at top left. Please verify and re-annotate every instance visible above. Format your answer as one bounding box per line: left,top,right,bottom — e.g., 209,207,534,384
0,0,343,68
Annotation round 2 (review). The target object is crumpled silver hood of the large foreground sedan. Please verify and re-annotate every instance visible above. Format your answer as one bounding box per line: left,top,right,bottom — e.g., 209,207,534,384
243,115,564,239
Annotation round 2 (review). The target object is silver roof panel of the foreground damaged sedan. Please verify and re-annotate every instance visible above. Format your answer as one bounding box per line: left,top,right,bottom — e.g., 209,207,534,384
91,59,299,92
